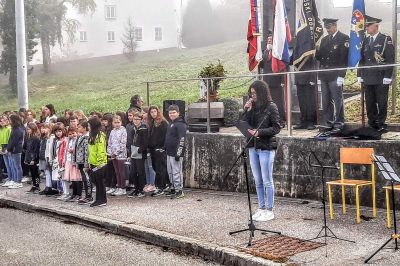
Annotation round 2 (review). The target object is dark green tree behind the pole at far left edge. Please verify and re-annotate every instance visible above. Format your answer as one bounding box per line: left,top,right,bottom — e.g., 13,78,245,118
0,0,38,92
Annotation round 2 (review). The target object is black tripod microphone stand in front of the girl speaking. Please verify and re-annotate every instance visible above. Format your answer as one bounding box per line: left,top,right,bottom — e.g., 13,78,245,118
224,111,281,247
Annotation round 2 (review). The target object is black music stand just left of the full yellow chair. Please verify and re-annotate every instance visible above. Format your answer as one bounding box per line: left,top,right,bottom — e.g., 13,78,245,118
306,150,355,245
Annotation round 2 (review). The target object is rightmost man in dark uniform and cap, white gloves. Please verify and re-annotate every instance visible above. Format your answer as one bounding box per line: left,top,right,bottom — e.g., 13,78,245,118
357,15,395,131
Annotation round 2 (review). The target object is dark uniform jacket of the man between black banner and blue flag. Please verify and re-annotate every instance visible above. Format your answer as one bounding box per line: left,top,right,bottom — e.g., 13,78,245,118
315,31,349,81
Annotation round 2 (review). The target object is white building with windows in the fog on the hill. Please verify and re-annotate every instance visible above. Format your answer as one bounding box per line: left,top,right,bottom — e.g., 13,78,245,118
31,0,183,64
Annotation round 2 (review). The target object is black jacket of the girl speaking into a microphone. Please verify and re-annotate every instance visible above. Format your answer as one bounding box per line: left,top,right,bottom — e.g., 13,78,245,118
243,102,281,150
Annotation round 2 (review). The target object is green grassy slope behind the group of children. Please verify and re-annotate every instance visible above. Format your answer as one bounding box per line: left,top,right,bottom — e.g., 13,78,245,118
0,42,249,113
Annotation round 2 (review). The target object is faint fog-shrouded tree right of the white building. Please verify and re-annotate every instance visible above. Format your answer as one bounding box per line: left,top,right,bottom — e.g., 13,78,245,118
182,0,220,48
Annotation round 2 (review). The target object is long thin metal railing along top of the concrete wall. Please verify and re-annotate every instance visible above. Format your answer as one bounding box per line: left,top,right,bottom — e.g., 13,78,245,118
143,64,400,136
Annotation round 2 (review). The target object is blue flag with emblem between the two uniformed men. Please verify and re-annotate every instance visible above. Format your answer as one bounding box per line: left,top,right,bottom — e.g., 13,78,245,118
348,0,365,67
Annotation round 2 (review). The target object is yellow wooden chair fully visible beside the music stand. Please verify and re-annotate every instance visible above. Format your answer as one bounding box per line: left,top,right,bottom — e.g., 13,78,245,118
326,148,376,223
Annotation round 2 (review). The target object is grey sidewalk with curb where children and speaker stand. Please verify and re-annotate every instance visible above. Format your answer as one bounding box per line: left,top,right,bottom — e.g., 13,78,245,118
0,186,400,265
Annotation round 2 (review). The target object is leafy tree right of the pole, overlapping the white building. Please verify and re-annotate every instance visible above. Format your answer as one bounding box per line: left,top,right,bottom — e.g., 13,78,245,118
36,0,96,73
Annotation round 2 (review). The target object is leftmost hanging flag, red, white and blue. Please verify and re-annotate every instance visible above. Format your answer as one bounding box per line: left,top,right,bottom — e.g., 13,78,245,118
247,0,262,71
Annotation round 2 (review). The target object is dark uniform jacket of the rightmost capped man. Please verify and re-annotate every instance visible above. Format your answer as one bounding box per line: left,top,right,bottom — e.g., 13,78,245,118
358,33,395,85
